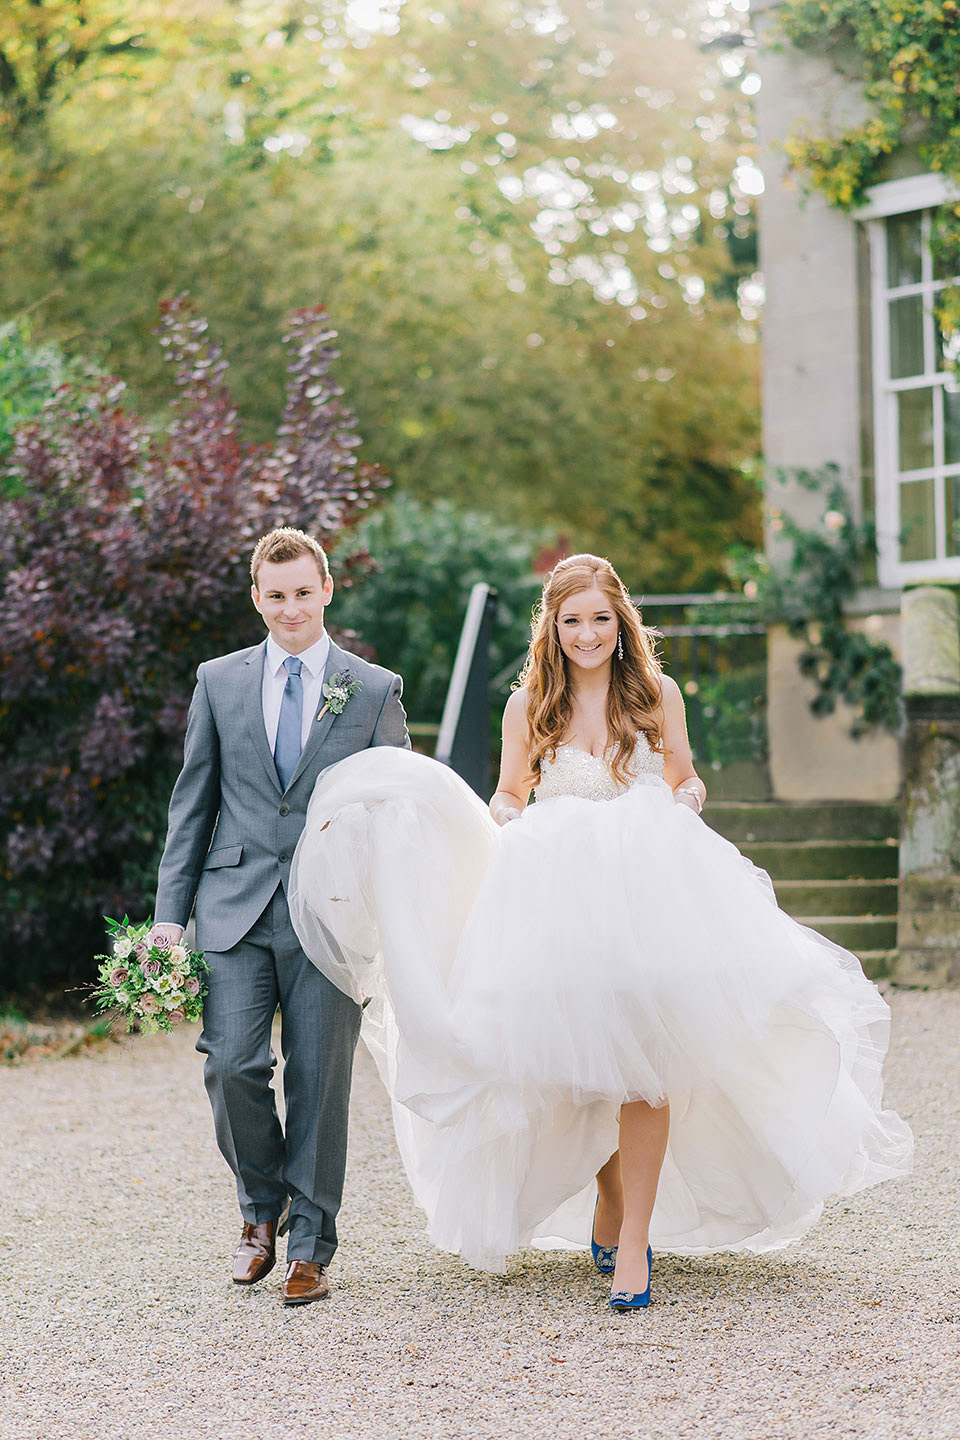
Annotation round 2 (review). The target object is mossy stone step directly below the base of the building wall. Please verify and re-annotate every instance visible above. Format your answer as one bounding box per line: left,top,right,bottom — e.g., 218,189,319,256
704,800,900,845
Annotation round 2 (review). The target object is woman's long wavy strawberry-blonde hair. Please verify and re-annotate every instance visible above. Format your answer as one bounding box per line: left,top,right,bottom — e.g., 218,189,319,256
517,554,664,785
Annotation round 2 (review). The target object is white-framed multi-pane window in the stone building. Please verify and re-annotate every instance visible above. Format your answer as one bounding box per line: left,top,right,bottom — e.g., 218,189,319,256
858,174,960,586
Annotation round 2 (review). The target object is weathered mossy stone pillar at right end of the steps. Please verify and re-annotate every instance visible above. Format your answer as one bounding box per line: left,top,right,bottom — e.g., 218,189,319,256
892,585,960,985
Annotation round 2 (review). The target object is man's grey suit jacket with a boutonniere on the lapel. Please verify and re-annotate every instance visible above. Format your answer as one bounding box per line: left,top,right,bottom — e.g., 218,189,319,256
154,641,410,950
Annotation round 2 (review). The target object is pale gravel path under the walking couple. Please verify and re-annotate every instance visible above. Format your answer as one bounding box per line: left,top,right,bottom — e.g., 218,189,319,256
0,992,960,1440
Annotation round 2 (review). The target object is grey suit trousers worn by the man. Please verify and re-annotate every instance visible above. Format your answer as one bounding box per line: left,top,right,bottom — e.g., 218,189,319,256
197,886,360,1264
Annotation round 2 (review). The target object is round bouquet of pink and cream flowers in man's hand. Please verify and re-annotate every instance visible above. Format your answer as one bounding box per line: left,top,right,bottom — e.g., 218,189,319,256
94,916,209,1031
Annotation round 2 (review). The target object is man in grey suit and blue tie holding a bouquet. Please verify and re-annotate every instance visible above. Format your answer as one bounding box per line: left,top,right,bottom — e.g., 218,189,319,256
154,528,410,1305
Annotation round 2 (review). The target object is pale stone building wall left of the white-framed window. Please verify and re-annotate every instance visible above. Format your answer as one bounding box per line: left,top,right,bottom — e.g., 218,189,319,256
751,0,900,801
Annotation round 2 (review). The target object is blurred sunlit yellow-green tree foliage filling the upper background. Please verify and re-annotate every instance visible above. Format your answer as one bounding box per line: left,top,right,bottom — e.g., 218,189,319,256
0,0,759,588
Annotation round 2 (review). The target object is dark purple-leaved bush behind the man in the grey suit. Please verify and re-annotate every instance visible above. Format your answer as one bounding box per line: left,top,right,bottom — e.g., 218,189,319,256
0,298,386,989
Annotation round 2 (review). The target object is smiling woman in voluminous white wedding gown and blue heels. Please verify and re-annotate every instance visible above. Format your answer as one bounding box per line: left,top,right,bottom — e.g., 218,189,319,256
291,554,913,1310
